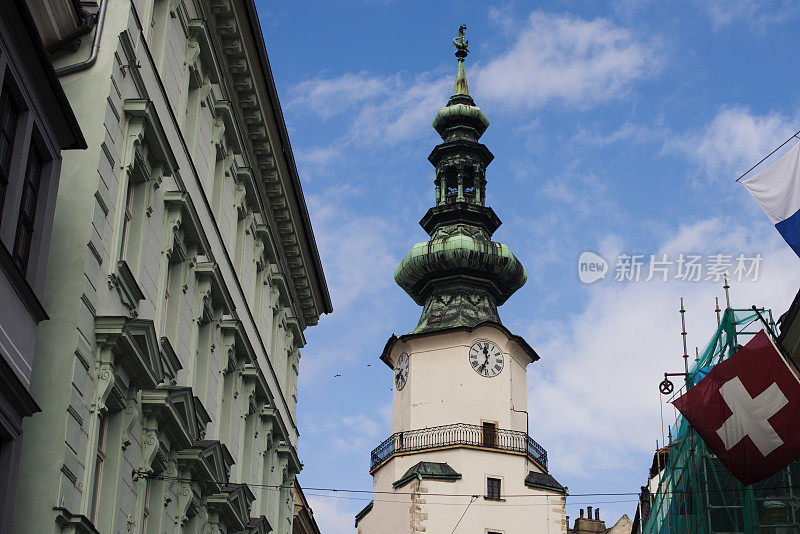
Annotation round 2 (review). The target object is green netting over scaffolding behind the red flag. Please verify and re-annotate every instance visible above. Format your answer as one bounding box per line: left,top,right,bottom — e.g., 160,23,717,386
643,308,800,534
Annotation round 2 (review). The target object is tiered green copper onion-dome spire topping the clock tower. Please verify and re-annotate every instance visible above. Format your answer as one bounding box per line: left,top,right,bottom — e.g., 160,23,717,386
394,26,527,333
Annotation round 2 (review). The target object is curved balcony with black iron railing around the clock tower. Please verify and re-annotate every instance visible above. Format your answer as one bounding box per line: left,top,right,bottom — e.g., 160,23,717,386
369,423,547,472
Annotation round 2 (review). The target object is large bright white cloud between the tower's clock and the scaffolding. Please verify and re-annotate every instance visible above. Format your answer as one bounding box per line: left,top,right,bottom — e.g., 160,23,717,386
528,219,800,486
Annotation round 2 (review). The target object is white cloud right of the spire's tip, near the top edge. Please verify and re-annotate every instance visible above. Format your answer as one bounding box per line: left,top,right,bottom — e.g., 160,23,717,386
476,11,658,108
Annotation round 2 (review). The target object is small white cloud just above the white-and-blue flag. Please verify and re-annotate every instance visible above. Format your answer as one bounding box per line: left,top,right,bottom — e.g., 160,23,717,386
665,107,795,181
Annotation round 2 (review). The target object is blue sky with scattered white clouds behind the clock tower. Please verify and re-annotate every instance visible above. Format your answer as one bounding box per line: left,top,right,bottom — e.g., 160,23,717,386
257,0,800,534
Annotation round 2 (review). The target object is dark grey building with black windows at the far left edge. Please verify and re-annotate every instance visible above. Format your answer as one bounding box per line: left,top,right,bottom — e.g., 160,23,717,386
0,0,86,534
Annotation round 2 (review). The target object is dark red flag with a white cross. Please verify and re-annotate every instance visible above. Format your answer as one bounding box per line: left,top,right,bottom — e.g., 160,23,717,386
673,330,800,485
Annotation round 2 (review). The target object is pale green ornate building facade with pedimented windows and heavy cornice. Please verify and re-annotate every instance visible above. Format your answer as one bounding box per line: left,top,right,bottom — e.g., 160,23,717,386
11,0,331,534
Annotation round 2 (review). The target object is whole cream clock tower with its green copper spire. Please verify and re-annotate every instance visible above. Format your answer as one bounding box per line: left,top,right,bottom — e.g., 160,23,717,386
356,26,567,534
